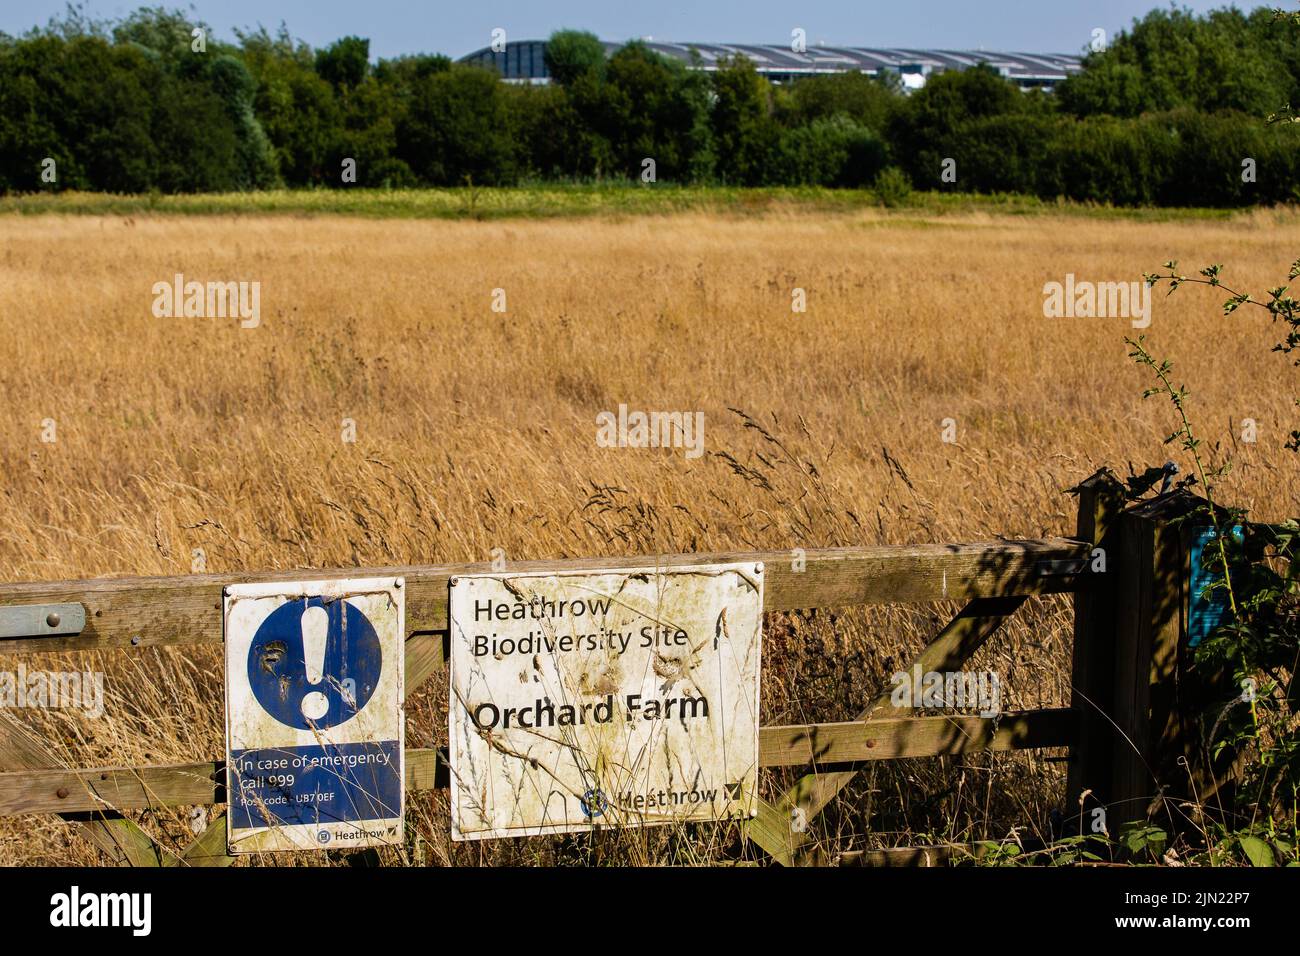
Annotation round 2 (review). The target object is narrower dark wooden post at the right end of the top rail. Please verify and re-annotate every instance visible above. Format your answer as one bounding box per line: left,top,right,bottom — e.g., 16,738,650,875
1065,468,1125,831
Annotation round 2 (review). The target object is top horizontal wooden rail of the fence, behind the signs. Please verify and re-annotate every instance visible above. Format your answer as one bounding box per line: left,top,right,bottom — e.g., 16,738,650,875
0,537,1087,653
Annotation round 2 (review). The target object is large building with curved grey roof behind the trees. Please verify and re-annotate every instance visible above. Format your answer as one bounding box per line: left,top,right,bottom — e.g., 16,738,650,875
460,40,1082,88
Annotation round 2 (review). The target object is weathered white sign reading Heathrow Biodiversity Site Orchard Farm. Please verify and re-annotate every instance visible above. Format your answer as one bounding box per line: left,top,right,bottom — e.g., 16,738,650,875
449,562,763,840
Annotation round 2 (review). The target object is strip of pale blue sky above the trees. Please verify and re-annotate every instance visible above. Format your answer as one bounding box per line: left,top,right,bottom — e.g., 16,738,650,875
0,0,1274,57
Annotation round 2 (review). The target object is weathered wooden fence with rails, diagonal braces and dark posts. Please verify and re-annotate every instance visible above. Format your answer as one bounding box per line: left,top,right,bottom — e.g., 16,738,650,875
0,470,1214,866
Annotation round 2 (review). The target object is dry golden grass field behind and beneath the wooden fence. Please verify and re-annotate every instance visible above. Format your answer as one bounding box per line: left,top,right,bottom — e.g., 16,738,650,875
0,208,1300,865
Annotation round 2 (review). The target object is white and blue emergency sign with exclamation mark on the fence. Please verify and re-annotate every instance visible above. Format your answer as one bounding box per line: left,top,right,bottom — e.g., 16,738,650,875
225,578,406,853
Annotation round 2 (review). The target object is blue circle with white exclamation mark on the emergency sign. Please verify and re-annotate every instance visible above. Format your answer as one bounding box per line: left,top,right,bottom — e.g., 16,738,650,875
248,597,384,730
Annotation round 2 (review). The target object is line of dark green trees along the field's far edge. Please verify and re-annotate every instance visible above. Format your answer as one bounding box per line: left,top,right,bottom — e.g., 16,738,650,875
0,8,1300,206
